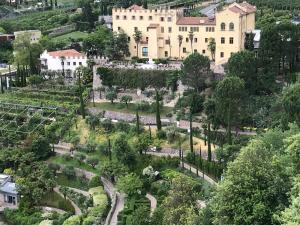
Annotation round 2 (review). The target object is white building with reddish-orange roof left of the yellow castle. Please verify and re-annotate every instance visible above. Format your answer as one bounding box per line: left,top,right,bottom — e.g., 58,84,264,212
40,49,87,74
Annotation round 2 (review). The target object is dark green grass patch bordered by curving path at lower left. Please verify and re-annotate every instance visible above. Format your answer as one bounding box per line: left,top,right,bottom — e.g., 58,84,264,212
40,191,75,213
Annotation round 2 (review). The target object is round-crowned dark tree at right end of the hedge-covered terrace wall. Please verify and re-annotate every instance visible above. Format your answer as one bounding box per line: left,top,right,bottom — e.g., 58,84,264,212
181,53,211,92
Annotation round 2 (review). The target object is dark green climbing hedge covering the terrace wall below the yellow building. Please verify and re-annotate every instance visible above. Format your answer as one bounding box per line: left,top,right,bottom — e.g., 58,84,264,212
97,67,174,90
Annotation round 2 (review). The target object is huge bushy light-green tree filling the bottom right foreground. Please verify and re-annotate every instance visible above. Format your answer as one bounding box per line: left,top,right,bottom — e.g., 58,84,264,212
212,137,289,225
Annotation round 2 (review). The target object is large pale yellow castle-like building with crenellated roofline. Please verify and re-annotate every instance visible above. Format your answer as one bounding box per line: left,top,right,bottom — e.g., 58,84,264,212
112,2,256,65
